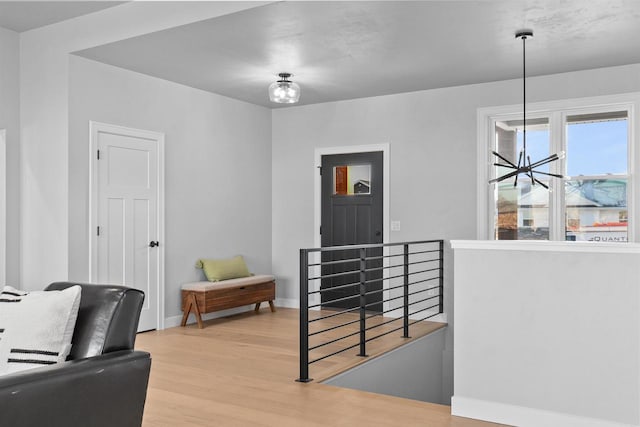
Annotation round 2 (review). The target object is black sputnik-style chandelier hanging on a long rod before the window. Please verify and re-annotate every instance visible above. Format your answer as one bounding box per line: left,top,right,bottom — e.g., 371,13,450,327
489,30,564,189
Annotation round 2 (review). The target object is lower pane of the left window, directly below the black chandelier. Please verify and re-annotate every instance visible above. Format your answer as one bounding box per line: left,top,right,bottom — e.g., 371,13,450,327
494,181,549,240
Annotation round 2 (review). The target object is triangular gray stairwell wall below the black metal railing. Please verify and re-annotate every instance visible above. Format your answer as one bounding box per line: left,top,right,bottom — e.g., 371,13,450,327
324,329,450,404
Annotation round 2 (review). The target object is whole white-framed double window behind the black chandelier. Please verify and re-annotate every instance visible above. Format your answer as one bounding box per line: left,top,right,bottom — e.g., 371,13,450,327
478,94,638,242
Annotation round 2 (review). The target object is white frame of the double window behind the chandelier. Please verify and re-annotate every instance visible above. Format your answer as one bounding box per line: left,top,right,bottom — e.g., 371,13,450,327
477,92,640,244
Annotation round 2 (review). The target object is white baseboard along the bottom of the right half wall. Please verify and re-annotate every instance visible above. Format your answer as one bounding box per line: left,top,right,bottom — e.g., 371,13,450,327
451,396,639,427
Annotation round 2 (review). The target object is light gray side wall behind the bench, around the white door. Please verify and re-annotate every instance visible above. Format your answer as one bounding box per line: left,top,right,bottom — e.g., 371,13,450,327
69,56,271,317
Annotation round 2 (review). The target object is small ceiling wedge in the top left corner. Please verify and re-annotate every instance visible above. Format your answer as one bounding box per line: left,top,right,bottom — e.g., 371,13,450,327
0,0,124,32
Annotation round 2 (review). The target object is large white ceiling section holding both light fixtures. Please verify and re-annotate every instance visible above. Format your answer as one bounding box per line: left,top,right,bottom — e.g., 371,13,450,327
0,0,640,107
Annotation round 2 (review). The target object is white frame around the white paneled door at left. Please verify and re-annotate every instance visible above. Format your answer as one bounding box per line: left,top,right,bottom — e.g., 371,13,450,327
89,120,165,330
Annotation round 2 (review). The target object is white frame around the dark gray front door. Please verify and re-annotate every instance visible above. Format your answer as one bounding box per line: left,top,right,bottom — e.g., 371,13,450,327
309,142,389,310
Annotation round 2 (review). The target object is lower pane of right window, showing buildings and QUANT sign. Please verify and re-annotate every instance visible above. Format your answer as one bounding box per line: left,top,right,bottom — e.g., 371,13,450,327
565,179,628,242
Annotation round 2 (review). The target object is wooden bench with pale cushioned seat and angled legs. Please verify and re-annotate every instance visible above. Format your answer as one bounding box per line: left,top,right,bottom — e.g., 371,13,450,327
180,275,276,329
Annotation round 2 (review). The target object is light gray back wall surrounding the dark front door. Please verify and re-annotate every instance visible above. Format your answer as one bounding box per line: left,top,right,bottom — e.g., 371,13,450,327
272,64,640,404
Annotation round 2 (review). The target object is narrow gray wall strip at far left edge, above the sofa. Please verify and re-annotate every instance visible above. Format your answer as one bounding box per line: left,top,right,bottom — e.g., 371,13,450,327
0,28,20,287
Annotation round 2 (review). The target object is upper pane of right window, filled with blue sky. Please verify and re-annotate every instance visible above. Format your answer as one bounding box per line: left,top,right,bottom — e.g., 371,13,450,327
567,111,627,177
